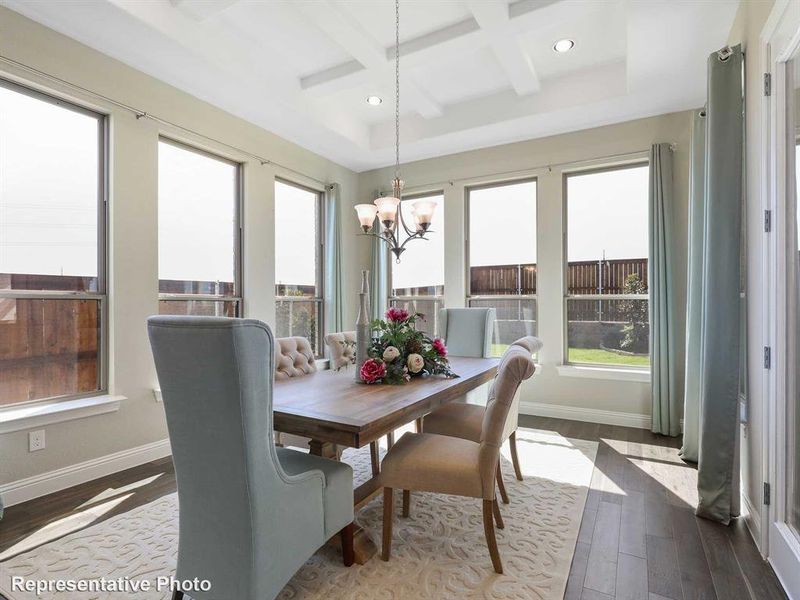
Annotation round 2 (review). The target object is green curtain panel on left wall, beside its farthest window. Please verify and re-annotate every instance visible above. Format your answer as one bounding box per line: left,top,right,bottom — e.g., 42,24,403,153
325,183,344,333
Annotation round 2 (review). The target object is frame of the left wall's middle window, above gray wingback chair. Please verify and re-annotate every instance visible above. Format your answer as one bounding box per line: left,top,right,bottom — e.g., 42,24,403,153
157,134,244,318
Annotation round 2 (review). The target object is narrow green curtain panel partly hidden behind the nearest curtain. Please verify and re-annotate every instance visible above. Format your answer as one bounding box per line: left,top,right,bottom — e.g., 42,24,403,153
681,108,706,462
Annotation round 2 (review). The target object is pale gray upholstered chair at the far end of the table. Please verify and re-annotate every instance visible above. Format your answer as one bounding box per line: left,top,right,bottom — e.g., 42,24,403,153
439,308,497,358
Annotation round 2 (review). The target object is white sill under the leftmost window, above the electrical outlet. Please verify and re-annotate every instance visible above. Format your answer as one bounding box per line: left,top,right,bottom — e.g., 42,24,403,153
0,394,126,434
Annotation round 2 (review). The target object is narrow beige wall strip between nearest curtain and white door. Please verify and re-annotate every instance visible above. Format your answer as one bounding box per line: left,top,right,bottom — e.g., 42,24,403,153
728,0,774,550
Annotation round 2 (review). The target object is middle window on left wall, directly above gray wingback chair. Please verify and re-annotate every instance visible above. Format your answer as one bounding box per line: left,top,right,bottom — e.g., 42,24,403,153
158,139,242,317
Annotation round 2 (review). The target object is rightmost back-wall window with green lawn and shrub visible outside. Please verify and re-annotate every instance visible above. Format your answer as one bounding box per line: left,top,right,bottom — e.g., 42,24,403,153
565,164,650,368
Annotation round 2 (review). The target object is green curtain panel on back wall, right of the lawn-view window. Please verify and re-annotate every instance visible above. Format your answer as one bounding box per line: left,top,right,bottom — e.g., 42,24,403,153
647,144,683,436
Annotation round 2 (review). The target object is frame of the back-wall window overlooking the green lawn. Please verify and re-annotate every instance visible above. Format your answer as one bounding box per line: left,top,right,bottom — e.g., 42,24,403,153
561,155,652,373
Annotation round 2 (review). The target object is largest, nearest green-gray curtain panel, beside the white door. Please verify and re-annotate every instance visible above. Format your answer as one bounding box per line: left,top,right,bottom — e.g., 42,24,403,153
697,46,744,524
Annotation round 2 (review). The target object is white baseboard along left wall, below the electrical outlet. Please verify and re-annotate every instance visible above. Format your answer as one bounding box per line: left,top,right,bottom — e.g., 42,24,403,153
0,439,172,507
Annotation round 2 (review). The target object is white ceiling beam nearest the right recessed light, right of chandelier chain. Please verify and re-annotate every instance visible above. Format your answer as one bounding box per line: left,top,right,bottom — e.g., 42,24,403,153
467,0,542,96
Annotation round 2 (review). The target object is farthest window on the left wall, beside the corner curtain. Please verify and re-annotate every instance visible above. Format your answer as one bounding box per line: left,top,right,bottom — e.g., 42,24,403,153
275,181,323,356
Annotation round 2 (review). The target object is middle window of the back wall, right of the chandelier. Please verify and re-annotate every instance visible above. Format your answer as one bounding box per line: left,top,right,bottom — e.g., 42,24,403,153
467,179,537,356
